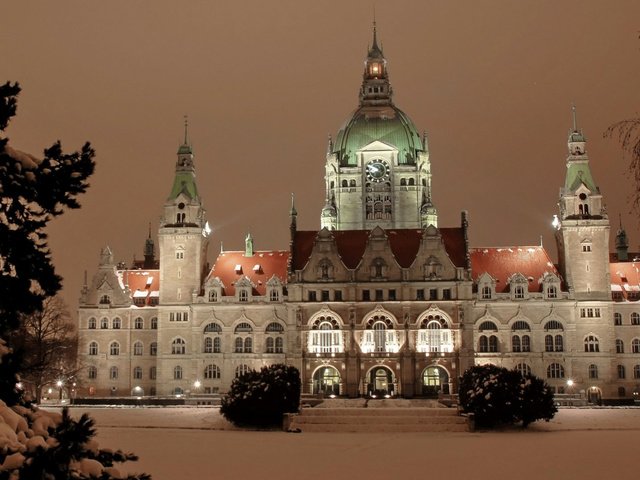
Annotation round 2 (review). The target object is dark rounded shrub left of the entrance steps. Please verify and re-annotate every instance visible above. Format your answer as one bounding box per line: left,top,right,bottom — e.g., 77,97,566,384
220,364,300,427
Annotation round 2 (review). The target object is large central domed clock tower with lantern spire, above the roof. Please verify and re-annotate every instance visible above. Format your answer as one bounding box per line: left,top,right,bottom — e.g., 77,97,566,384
321,23,438,230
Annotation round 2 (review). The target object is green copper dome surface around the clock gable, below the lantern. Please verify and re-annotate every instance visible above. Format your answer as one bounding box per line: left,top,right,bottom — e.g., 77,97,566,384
332,104,424,167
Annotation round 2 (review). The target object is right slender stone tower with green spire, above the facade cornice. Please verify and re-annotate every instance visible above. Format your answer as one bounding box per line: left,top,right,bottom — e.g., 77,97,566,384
556,107,611,300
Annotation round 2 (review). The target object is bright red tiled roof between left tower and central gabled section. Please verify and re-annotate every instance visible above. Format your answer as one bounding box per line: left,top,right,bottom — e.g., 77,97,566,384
207,250,289,296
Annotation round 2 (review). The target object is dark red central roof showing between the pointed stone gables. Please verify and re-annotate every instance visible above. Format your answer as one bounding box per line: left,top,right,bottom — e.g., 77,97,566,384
293,228,465,270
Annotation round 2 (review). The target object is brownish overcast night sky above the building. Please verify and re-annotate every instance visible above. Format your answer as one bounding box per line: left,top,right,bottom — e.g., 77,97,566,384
0,0,640,314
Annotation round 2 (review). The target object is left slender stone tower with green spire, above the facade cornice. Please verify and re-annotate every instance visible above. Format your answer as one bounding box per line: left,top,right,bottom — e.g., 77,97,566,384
158,122,210,304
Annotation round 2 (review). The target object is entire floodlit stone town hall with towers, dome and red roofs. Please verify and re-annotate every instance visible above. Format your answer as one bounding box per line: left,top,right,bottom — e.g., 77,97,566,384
79,28,640,401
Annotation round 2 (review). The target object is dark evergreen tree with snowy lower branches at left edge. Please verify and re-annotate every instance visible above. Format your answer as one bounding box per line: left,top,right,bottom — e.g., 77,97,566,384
0,82,150,480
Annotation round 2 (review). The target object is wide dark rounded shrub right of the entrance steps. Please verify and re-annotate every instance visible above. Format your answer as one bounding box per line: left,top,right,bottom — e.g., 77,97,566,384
459,365,557,428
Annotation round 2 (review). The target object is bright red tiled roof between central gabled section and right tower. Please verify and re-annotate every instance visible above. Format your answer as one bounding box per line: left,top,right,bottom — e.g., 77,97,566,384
470,246,560,293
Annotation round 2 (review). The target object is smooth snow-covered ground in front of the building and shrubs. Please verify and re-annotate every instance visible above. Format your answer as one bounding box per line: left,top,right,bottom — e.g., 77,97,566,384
53,407,640,480
